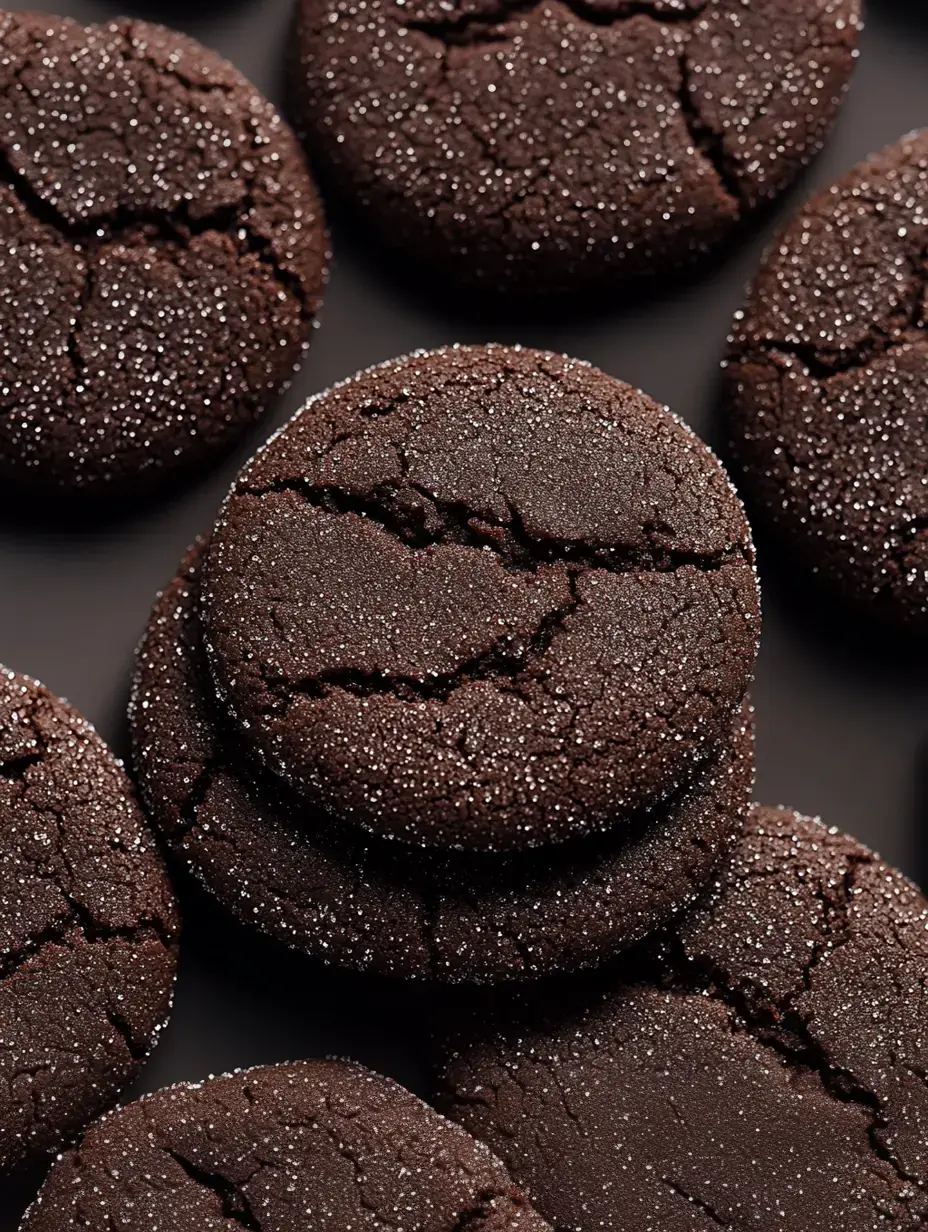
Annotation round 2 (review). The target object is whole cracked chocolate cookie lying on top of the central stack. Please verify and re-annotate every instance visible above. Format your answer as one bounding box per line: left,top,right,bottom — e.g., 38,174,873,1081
203,346,759,850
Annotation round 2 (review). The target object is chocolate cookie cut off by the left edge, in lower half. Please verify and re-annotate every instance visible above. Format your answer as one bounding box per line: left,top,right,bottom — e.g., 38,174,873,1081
0,669,179,1173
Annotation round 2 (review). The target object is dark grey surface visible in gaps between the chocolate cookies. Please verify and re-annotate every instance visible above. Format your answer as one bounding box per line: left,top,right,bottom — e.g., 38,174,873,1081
0,0,928,1232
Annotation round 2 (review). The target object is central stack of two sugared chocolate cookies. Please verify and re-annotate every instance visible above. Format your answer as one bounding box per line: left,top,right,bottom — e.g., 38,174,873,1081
132,346,759,981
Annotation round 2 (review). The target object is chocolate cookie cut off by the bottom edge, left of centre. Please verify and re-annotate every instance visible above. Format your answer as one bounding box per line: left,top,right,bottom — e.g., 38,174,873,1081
22,1061,550,1232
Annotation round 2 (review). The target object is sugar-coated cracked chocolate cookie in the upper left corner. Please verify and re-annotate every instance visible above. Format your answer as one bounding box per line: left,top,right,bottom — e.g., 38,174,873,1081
0,12,327,490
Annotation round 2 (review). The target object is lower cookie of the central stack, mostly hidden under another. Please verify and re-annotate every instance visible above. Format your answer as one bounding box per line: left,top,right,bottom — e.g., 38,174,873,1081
132,547,753,982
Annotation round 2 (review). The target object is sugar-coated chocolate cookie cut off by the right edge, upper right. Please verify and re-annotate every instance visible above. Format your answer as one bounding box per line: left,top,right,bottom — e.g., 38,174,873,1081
726,129,928,631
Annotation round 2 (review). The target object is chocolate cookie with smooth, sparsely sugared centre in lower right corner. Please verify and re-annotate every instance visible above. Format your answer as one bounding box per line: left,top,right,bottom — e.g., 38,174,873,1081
439,808,928,1232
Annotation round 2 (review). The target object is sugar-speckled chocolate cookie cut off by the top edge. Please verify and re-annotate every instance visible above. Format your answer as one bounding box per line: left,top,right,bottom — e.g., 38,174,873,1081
293,0,859,296
